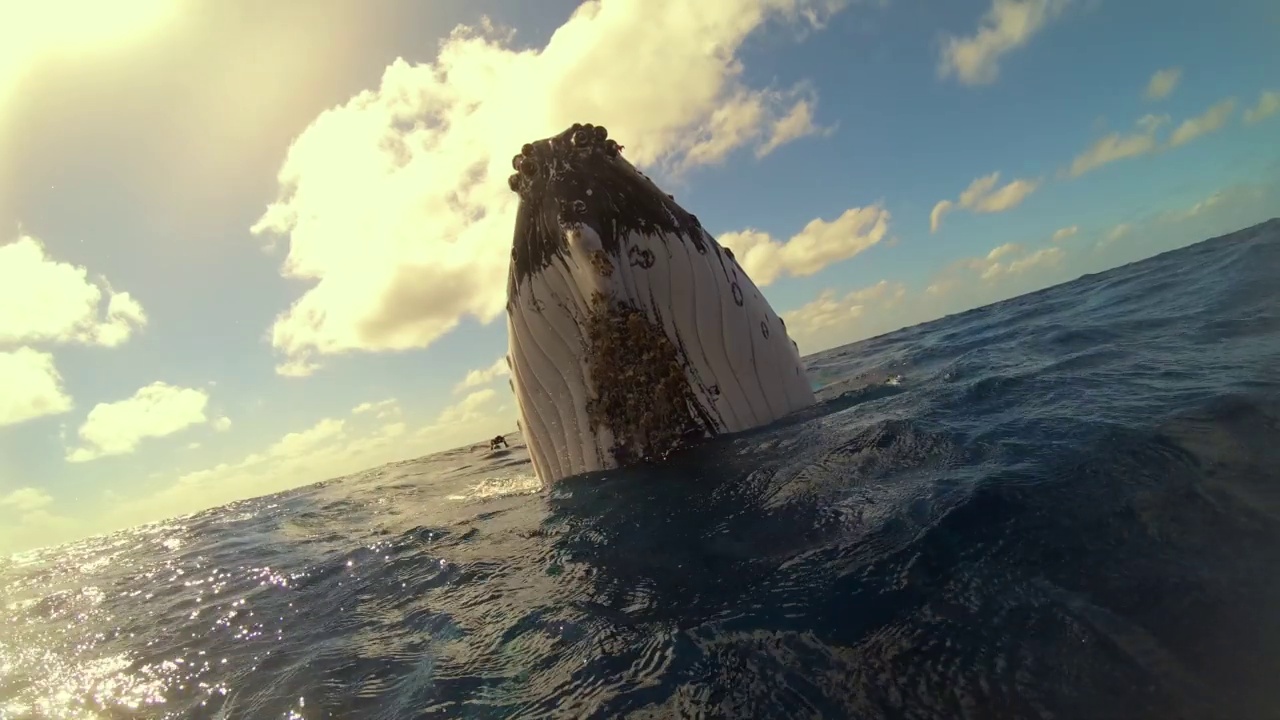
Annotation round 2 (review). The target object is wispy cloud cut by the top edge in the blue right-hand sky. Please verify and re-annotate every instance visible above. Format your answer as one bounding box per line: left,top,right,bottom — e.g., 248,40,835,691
938,0,1069,85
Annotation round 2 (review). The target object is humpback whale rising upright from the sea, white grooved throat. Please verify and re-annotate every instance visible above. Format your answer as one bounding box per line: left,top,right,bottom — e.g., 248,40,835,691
507,123,815,484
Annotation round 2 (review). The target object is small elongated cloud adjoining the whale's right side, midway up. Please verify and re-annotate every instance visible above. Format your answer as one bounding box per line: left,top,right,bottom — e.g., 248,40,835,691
717,204,890,287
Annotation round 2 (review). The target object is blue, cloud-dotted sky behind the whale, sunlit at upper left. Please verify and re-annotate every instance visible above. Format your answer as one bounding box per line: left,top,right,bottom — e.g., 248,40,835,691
0,0,1280,552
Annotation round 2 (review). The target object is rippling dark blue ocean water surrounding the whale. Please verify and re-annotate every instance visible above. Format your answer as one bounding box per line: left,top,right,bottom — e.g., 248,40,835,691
0,220,1280,720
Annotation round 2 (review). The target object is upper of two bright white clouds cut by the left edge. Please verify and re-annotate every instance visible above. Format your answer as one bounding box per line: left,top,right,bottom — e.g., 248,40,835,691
0,236,147,347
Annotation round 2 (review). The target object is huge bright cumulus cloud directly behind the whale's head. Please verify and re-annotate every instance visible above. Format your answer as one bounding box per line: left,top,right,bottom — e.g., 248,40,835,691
252,0,845,375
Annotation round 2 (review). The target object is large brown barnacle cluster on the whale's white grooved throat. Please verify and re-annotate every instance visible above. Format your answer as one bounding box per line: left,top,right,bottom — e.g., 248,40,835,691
586,292,707,465
